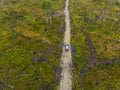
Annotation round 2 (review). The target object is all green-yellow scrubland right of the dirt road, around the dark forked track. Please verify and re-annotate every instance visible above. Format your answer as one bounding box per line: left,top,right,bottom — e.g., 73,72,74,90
69,0,120,90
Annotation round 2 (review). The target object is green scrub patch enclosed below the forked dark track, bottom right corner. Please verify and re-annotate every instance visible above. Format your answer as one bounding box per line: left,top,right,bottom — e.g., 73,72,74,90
83,63,120,90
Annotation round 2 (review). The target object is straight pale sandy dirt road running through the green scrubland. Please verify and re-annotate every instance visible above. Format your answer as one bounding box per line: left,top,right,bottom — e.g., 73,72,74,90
59,0,72,90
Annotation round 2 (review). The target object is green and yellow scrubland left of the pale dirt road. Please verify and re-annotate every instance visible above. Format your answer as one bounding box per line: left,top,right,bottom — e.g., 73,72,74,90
0,0,64,90
